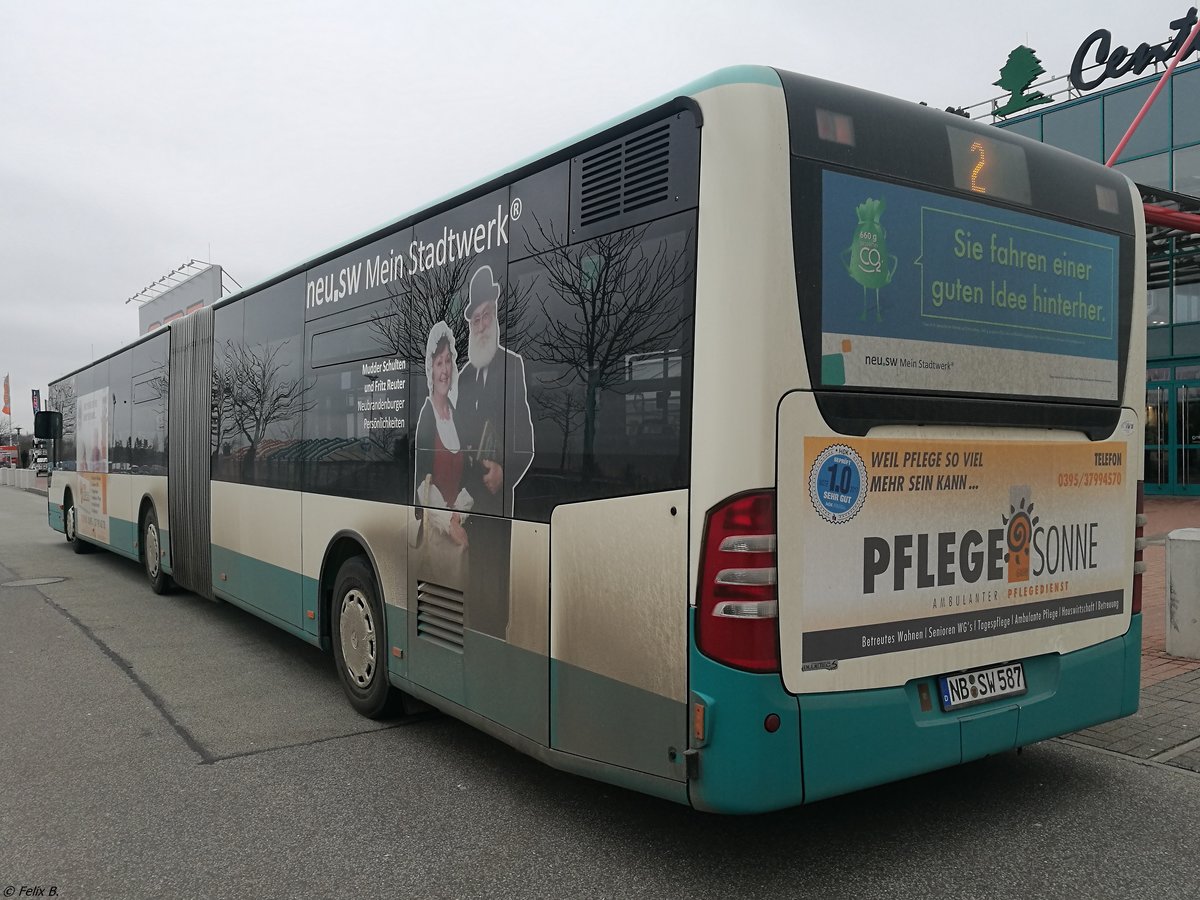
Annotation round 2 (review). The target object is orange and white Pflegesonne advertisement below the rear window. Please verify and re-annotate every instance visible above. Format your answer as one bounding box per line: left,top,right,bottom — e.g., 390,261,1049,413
786,437,1133,671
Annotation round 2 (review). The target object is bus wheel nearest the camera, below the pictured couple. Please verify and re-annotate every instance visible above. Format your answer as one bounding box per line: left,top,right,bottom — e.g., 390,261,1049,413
330,557,391,719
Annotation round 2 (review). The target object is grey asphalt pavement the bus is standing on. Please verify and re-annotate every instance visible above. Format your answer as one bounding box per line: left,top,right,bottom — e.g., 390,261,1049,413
0,488,1200,899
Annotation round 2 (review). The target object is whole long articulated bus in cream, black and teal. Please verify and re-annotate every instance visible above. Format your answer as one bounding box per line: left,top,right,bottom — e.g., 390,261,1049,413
38,67,1146,812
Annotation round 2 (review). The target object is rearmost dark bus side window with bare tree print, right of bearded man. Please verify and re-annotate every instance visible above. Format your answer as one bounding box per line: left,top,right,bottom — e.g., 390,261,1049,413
508,212,696,521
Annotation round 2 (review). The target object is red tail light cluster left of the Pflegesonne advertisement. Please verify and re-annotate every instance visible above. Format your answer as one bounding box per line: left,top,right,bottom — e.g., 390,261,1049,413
696,491,779,672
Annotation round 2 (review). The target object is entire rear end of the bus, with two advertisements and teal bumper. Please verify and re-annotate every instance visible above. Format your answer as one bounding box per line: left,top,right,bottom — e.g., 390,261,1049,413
689,72,1145,812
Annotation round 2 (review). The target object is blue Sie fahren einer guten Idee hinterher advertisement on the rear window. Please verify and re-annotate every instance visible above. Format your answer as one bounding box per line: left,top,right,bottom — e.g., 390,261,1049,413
821,172,1120,401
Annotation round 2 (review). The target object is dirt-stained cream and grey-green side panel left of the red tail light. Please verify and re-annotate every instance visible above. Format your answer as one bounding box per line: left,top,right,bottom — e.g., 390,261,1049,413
550,491,688,781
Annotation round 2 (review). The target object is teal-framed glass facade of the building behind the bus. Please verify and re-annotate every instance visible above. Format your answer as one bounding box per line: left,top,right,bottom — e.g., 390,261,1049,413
996,64,1200,494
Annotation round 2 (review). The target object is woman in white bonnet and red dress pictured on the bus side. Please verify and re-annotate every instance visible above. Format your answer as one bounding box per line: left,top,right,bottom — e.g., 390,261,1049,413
414,322,474,583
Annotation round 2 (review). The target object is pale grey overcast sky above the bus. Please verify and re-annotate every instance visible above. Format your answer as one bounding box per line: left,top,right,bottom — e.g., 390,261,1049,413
0,0,1189,430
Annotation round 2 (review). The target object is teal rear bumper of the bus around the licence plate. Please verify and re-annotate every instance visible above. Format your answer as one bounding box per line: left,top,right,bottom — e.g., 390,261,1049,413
689,614,1142,814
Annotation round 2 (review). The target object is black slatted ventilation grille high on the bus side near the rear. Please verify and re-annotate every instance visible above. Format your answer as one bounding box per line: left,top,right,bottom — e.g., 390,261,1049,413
580,122,671,228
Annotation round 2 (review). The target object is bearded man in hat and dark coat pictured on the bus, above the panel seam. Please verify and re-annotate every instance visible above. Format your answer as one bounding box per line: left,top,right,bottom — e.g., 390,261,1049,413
456,265,533,516
